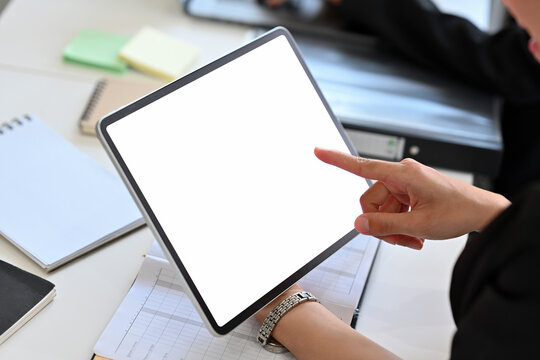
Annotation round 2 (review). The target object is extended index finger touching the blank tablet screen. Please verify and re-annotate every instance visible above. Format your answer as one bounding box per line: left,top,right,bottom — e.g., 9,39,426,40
315,148,401,181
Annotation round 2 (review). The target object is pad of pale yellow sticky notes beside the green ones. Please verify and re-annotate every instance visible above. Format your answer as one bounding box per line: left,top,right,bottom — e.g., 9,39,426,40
119,27,199,81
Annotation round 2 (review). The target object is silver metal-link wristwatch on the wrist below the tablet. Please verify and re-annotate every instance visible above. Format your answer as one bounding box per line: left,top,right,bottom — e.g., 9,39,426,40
257,291,319,353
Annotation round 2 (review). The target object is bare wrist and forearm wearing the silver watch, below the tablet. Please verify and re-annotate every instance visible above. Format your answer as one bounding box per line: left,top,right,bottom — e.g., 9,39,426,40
255,285,398,360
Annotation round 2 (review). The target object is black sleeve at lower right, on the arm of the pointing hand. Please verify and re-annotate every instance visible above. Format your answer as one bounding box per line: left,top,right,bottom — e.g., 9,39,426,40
450,184,540,359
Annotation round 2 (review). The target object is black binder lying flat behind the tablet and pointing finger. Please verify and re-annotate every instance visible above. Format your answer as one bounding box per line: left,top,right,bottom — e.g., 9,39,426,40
296,35,503,176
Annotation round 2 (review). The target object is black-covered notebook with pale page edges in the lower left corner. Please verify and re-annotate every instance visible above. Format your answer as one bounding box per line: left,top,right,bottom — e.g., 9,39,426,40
0,260,56,344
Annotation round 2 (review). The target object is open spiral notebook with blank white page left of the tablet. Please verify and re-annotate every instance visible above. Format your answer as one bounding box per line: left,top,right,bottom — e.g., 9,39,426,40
0,115,144,271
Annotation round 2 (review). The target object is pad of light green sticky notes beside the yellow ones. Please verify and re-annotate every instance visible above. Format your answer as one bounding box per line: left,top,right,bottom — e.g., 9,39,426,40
63,29,129,72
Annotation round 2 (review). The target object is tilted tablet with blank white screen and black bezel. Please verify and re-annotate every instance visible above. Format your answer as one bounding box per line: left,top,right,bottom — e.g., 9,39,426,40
98,28,369,334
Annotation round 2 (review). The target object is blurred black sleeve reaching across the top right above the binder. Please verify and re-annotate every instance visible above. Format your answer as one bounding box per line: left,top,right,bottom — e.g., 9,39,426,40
339,0,540,103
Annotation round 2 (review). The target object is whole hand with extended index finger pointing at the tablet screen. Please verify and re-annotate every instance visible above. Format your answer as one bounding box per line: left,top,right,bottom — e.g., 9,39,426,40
315,148,510,249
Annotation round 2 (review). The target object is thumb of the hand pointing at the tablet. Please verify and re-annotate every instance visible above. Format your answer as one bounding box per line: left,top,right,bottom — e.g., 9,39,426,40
354,212,419,236
